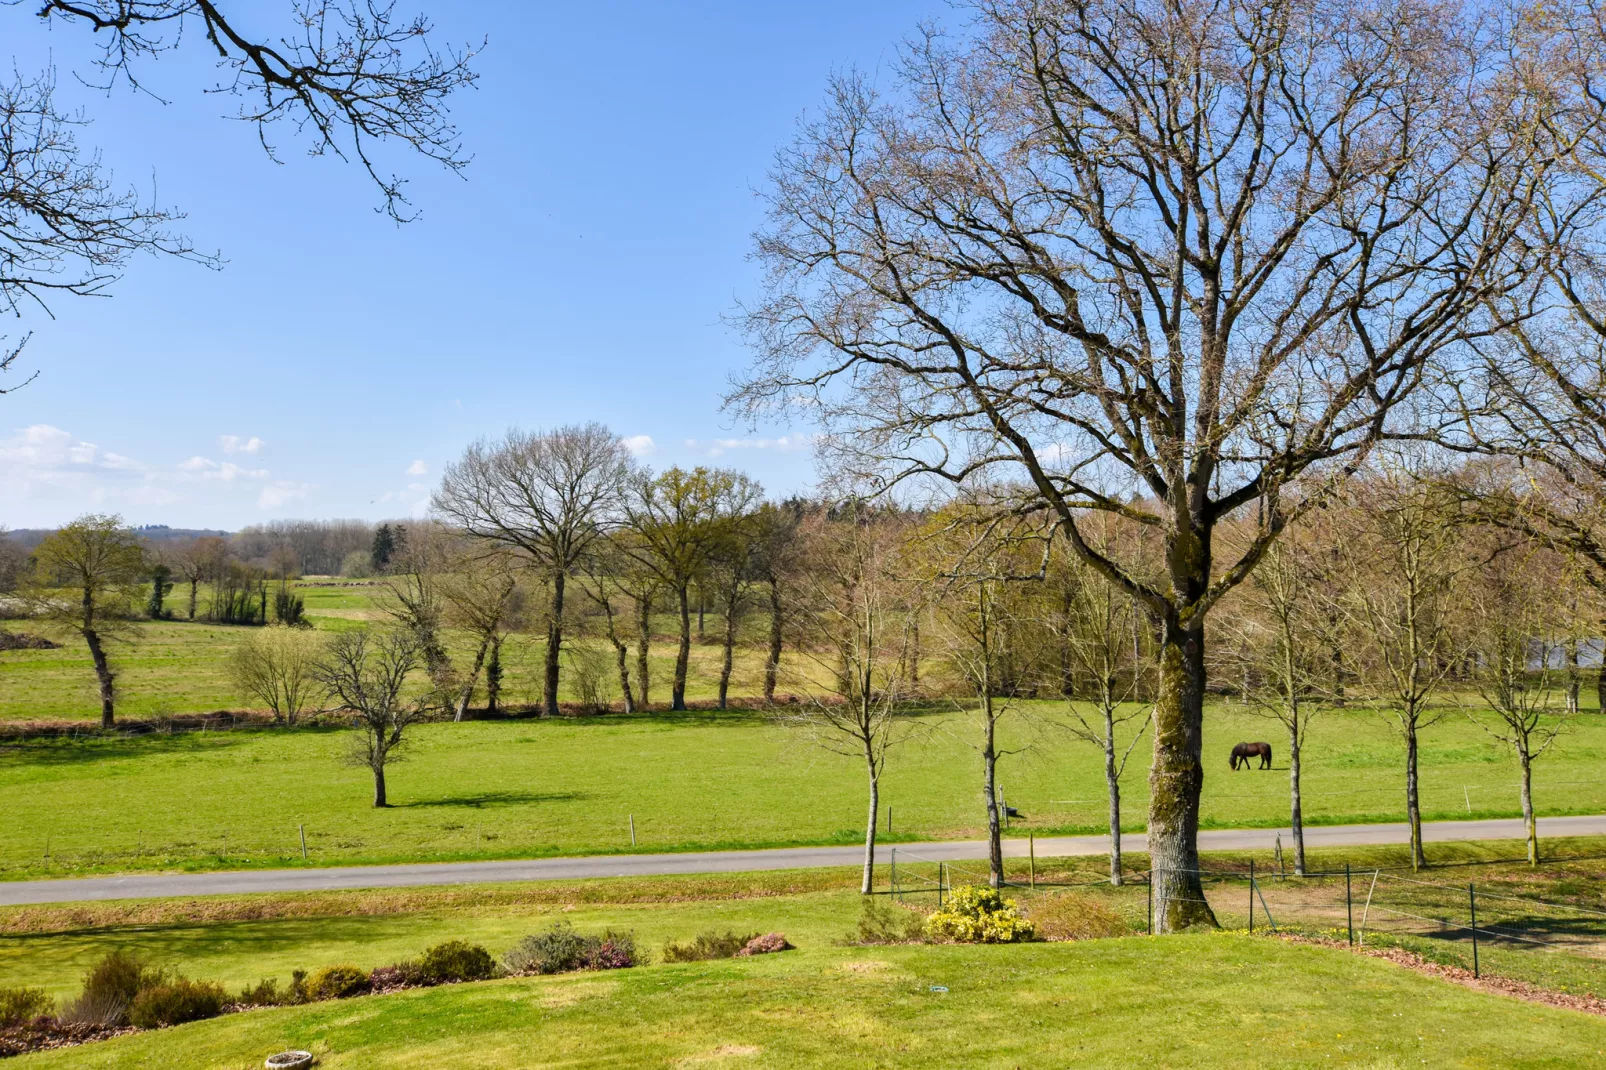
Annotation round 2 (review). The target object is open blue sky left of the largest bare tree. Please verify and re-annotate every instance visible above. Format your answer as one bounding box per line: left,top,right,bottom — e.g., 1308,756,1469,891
0,0,952,529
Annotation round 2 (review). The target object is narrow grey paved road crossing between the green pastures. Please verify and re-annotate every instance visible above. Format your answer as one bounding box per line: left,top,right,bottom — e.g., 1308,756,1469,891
0,815,1606,906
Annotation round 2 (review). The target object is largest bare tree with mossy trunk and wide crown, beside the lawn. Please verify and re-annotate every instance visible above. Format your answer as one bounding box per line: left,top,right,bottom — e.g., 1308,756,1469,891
731,0,1558,930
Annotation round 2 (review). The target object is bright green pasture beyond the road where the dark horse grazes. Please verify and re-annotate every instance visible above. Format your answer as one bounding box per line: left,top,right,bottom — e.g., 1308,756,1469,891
0,702,1606,879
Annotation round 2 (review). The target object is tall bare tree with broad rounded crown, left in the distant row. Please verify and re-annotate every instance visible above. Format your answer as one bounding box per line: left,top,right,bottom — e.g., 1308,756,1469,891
434,424,631,717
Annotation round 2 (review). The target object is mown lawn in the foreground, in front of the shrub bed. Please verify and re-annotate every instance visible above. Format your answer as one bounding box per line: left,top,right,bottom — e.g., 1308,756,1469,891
14,935,1606,1070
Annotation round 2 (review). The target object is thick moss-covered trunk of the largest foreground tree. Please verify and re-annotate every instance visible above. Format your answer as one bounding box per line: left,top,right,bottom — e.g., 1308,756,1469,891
1148,615,1216,932
